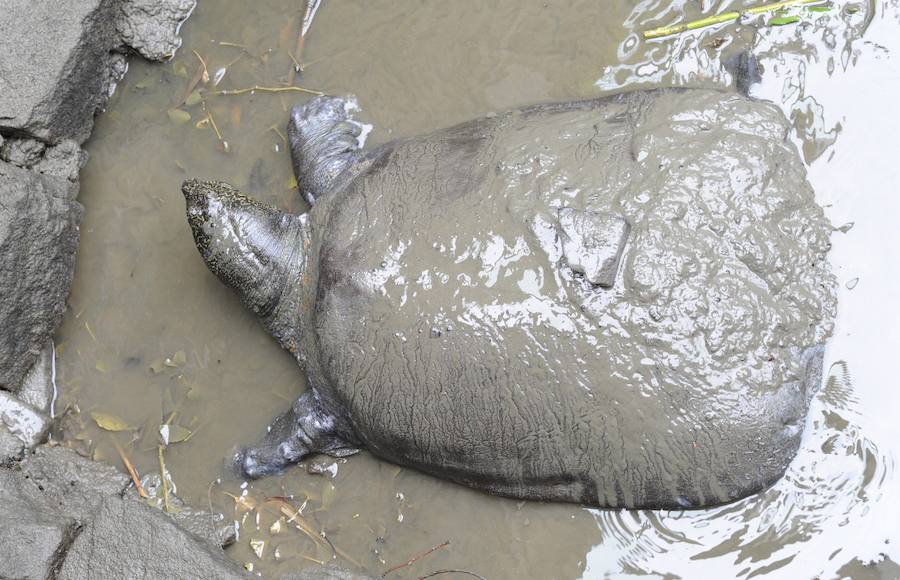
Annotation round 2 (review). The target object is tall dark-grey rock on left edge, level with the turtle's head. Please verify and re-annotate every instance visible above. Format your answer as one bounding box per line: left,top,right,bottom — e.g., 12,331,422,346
0,161,83,390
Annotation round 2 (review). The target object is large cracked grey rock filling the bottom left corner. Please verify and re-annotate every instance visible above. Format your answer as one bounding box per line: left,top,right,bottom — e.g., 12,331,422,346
0,446,250,578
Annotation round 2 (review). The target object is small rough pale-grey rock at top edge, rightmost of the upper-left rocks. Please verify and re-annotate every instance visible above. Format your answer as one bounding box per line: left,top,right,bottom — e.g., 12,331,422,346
116,0,197,61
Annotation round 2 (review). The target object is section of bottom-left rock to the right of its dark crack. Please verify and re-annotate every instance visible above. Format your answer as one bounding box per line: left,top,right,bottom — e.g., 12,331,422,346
57,497,244,580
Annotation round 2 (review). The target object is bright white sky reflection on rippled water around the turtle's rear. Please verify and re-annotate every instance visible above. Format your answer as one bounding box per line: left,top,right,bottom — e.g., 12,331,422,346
584,2,900,578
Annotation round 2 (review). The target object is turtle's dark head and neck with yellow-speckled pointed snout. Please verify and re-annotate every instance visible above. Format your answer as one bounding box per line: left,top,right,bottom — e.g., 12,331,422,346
181,179,306,321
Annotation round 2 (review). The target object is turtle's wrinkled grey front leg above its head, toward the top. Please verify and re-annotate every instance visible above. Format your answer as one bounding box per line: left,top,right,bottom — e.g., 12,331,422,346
288,96,362,205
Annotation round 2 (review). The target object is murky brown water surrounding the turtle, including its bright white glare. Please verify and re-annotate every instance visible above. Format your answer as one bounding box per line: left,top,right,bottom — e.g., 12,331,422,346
57,0,900,579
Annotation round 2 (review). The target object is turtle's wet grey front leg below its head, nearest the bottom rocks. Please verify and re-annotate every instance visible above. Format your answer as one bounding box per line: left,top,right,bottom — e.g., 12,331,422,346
235,389,359,479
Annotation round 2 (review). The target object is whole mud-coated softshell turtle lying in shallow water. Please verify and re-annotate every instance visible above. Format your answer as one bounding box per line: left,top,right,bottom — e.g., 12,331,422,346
183,89,835,508
